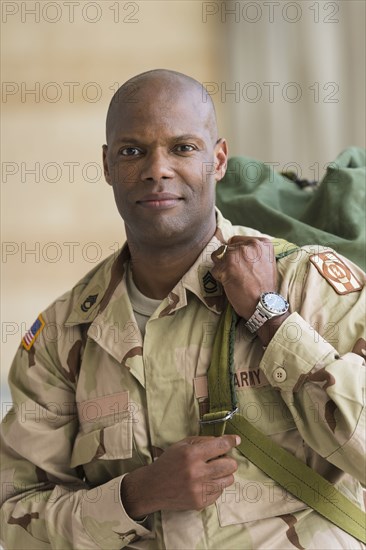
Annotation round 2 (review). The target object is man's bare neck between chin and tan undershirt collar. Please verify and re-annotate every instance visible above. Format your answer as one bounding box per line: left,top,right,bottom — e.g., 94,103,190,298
127,224,215,300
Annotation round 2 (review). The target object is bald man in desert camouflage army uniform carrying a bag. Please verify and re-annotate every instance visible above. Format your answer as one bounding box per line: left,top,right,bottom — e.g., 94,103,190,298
2,70,365,549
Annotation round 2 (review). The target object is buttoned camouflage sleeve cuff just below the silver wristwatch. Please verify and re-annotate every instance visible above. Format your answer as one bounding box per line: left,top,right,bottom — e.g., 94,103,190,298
260,313,337,391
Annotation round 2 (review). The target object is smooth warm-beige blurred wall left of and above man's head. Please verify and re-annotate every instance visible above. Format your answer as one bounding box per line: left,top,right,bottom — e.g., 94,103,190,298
1,0,227,398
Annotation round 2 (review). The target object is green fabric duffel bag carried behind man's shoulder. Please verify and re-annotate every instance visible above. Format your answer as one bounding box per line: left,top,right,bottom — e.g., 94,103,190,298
216,147,366,270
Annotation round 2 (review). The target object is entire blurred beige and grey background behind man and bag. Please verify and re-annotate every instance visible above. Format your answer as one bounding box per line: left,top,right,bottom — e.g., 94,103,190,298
1,0,365,406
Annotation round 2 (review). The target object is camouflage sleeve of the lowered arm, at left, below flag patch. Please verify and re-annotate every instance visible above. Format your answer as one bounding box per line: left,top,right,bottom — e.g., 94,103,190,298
1,304,150,550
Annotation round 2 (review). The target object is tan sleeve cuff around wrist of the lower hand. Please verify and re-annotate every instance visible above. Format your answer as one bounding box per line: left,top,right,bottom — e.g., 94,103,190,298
81,474,151,549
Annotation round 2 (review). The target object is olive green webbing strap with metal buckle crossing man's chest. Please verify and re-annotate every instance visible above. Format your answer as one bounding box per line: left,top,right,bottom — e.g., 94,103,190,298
201,241,366,543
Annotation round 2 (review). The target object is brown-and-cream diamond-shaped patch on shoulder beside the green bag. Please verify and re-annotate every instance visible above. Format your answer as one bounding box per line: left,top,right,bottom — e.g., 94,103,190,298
309,250,363,294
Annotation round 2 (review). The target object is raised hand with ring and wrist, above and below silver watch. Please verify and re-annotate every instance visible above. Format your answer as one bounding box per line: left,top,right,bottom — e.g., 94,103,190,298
211,236,289,346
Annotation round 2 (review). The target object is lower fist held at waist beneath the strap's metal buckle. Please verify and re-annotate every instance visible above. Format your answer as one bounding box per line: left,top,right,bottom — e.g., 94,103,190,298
121,435,240,519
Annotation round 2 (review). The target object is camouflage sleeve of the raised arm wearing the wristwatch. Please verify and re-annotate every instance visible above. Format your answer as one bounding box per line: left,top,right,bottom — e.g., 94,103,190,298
260,254,366,483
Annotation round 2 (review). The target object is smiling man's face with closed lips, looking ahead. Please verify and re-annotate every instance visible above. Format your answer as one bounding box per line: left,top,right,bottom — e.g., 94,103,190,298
103,83,227,252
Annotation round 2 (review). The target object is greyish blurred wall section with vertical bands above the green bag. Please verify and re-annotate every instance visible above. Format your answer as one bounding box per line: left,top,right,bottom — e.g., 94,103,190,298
226,0,366,175
